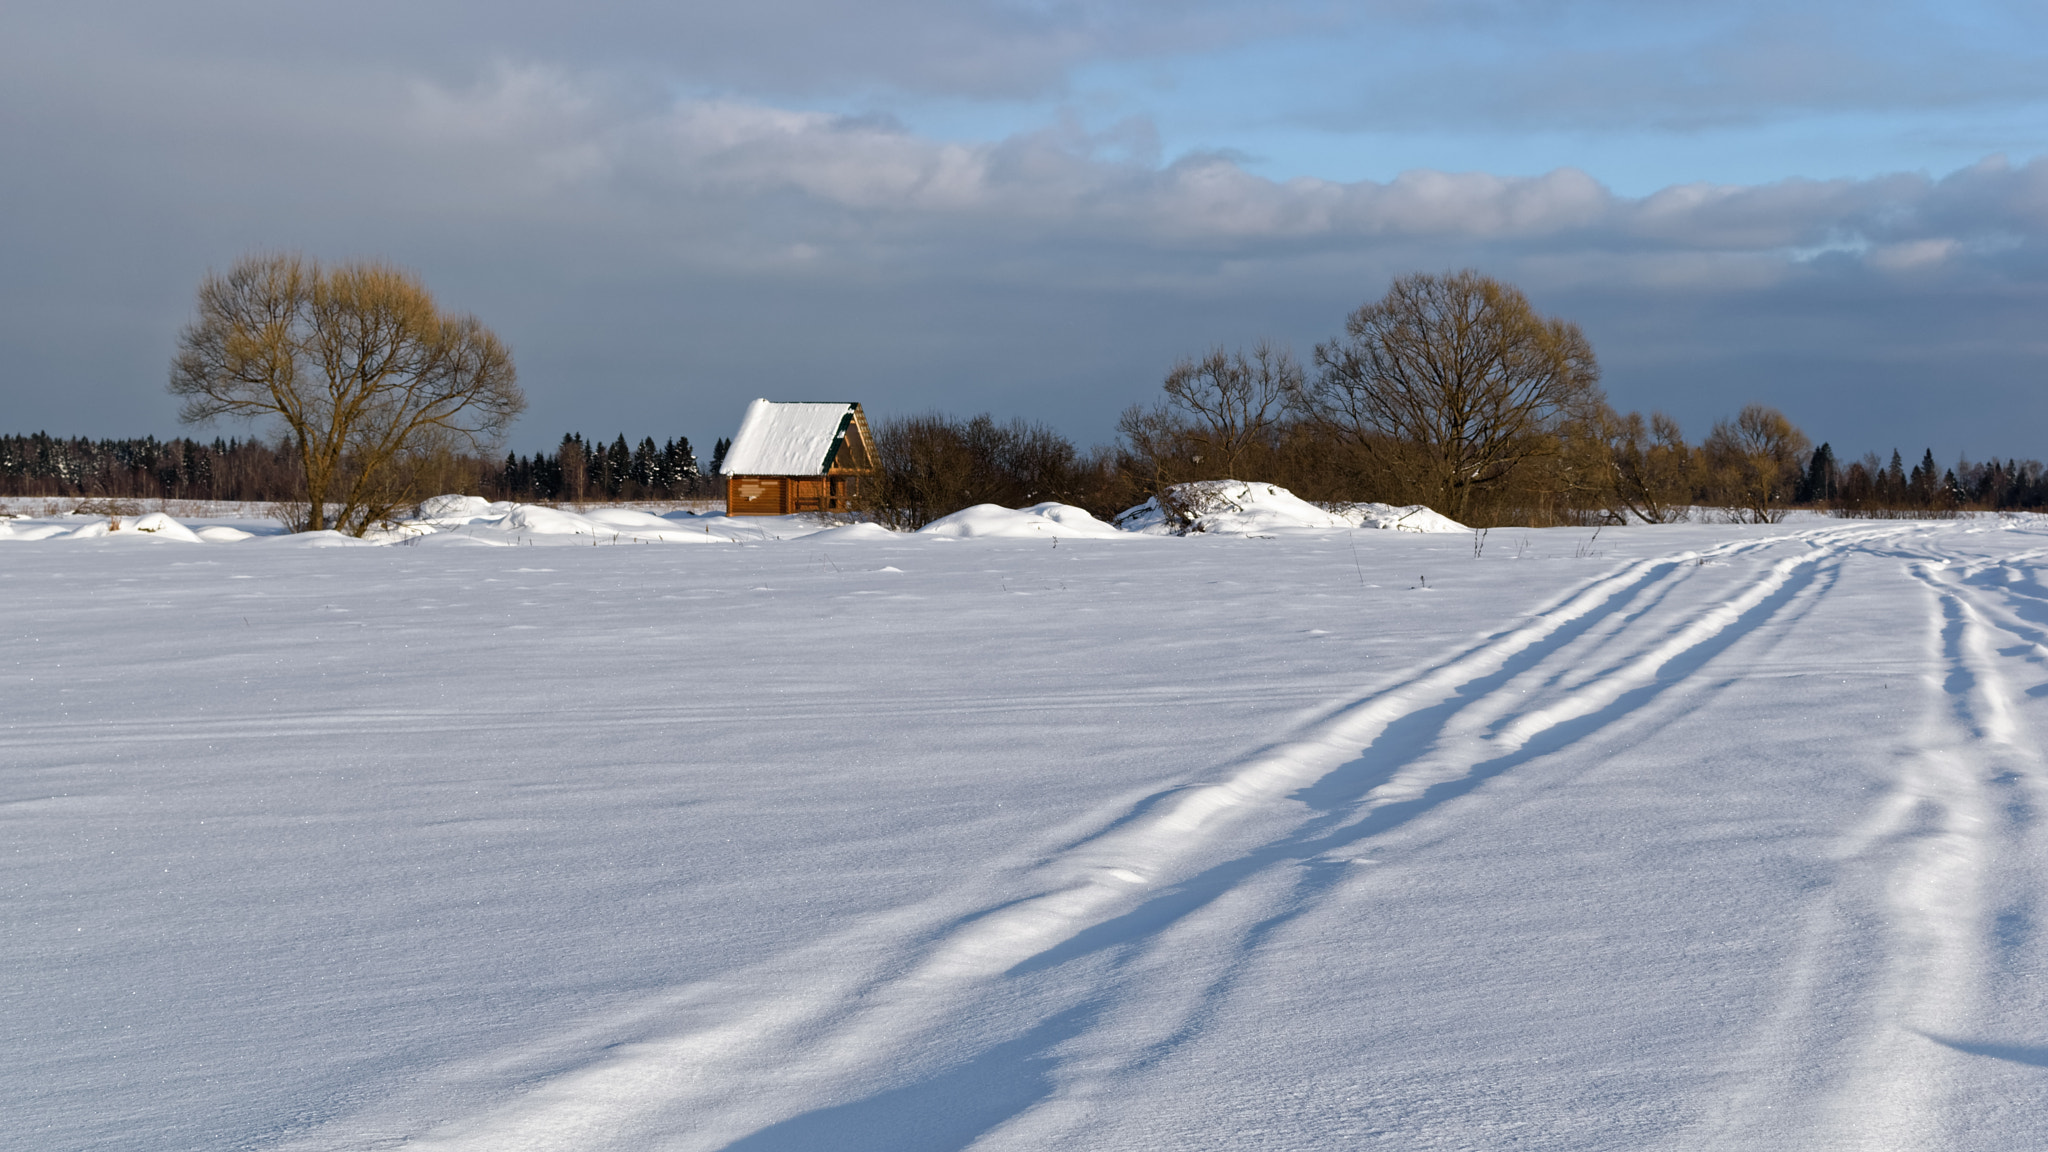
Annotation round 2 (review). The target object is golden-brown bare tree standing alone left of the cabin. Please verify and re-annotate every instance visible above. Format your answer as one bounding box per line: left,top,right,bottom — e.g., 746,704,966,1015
170,254,526,535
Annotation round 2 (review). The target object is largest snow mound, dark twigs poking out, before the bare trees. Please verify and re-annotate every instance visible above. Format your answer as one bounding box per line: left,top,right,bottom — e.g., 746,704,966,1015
1116,480,1470,535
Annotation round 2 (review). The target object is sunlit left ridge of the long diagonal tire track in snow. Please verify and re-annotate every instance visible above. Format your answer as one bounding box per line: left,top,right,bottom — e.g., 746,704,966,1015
276,545,1712,1150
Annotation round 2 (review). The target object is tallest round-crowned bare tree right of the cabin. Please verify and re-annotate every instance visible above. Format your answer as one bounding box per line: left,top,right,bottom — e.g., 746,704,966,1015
1296,271,1606,517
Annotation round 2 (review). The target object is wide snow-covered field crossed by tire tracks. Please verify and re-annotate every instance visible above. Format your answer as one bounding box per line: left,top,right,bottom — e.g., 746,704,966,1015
0,510,2048,1152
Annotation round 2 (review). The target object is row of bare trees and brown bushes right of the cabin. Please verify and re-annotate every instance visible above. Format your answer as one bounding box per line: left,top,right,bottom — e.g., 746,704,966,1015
868,271,2048,527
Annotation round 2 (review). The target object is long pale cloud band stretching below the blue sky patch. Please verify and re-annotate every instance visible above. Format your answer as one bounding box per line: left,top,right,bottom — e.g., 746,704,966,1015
376,68,2048,279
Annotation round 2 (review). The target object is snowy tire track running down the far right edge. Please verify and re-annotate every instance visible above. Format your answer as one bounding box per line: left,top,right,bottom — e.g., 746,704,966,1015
1688,541,2042,1150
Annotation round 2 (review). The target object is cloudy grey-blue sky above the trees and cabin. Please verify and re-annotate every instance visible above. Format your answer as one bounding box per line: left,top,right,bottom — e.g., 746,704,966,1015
0,0,2048,459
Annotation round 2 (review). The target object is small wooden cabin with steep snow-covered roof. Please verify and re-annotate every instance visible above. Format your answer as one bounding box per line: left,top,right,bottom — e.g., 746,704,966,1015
723,400,874,517
